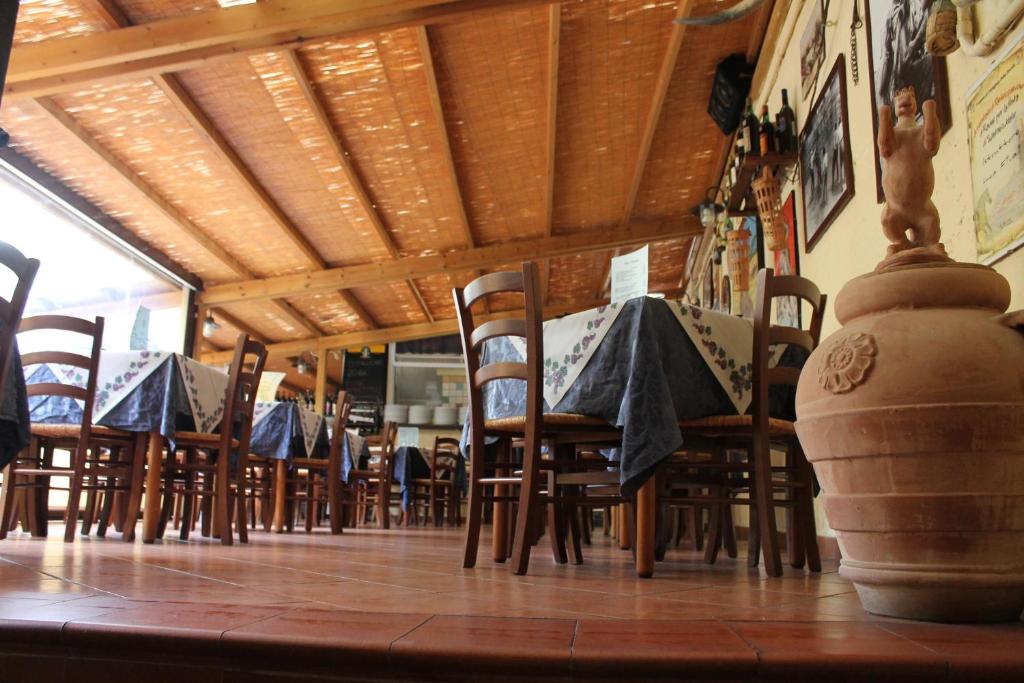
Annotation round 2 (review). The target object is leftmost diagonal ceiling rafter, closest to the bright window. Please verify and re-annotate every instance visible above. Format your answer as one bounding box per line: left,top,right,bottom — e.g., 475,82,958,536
36,97,322,334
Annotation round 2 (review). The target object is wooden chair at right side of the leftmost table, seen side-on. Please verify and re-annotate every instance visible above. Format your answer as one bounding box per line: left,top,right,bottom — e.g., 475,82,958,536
161,334,266,546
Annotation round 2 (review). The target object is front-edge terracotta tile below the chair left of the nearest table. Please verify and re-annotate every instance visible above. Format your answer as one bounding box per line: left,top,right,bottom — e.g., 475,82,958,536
391,616,575,673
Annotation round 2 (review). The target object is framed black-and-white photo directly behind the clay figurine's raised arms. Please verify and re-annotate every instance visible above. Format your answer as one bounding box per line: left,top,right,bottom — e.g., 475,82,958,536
864,0,952,202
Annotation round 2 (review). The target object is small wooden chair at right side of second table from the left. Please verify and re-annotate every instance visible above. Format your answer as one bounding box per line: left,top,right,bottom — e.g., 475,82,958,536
286,390,352,535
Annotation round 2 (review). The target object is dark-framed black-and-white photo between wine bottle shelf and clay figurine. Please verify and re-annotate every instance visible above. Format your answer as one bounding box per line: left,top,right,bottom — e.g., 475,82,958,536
800,54,853,252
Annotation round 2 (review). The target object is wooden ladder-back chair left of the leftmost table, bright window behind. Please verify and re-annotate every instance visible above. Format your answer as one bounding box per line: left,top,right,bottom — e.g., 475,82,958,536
0,315,144,543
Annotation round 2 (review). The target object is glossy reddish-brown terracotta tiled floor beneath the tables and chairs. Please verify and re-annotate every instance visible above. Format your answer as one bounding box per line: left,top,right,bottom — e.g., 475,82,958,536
0,528,1024,683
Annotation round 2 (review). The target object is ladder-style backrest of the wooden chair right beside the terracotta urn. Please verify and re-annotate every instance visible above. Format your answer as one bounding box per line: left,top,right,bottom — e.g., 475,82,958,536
751,268,827,427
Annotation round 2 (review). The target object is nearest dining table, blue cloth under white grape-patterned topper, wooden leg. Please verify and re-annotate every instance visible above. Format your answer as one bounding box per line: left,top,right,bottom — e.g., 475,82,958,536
462,296,807,577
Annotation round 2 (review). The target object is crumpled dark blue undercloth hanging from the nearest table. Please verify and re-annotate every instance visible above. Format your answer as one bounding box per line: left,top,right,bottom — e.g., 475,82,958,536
463,297,807,496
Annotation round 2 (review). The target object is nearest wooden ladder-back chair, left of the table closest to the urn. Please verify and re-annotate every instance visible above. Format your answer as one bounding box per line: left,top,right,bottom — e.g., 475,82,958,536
453,262,622,574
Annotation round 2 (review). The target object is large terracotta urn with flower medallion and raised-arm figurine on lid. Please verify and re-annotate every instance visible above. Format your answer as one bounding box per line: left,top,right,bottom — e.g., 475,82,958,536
797,91,1024,622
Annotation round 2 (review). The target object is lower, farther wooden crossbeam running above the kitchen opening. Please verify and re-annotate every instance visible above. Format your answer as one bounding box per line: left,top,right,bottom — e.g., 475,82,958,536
195,290,685,362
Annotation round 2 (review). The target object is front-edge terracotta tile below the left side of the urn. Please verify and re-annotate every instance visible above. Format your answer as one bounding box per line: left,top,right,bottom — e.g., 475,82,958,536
729,622,946,680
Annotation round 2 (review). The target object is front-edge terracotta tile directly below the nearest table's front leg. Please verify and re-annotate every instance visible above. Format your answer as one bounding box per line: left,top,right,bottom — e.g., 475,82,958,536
572,618,758,679
